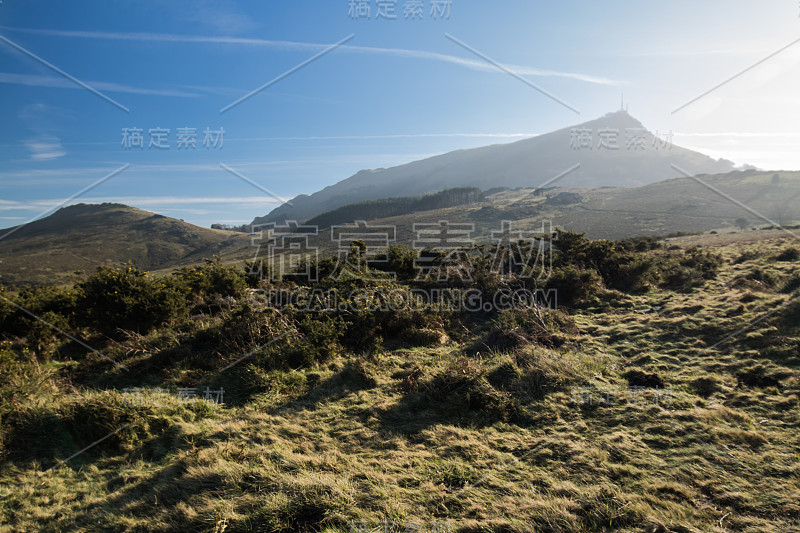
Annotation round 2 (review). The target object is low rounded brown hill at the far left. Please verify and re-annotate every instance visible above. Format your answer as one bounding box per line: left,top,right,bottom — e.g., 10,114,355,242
0,203,250,285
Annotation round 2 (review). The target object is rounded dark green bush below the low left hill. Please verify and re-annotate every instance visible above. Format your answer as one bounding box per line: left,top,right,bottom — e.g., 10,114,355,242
76,265,186,334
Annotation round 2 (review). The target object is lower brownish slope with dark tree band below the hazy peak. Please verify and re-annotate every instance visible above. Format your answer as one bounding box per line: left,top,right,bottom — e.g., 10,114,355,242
286,170,800,256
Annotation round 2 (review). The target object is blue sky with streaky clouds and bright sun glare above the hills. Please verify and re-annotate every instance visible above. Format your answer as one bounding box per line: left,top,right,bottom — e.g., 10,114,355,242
0,0,800,227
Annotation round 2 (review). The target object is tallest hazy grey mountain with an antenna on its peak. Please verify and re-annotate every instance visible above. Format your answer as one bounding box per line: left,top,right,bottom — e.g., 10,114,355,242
253,111,733,224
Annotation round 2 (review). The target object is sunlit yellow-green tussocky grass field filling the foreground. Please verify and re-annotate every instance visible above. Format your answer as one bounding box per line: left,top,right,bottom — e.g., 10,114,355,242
0,231,800,533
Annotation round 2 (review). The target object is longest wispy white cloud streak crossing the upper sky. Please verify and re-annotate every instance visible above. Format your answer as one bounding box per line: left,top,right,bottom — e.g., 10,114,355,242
3,27,622,85
